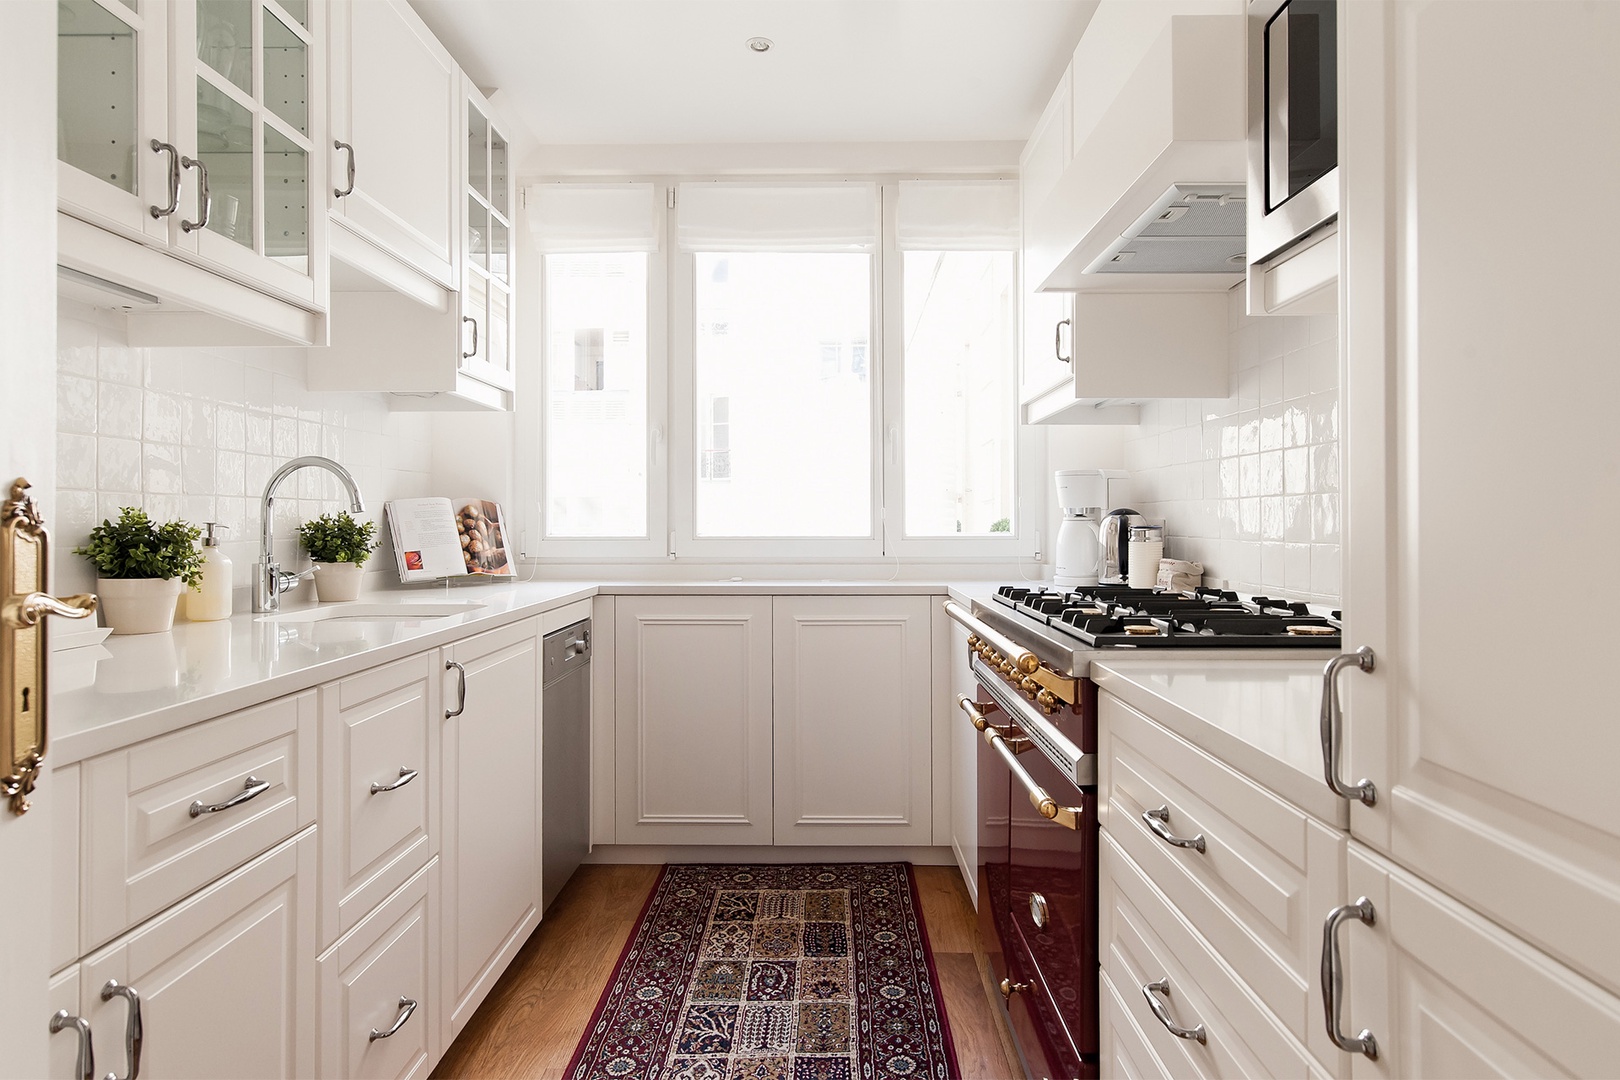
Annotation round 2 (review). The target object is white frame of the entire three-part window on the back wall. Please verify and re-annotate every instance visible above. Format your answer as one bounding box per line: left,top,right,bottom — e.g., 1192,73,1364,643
514,173,1047,568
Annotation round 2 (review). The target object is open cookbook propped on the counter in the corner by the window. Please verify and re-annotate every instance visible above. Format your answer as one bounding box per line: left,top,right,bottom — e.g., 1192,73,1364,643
387,499,515,583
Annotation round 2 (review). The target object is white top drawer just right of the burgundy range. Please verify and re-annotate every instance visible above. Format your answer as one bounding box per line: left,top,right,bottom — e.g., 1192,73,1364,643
1102,696,1346,1069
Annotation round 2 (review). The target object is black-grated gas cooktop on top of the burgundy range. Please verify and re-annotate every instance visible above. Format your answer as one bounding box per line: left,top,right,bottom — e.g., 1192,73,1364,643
995,585,1340,649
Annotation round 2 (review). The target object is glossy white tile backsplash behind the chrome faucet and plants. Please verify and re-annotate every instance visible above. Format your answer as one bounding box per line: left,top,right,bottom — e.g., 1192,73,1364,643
55,304,433,610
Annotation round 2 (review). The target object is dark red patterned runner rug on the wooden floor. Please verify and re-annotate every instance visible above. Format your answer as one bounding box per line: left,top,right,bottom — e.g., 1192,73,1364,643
565,863,957,1080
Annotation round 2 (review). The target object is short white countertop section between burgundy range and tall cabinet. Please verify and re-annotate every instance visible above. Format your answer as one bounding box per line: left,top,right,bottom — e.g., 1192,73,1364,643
1090,656,1349,826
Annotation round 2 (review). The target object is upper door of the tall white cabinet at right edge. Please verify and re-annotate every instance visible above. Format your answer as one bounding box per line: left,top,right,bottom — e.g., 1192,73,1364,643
1340,3,1620,997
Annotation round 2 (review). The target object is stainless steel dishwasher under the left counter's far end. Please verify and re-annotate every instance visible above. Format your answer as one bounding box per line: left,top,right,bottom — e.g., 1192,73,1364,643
539,619,591,912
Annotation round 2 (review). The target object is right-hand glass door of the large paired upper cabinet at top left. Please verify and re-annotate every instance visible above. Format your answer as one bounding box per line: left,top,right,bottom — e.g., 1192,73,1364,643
172,0,326,304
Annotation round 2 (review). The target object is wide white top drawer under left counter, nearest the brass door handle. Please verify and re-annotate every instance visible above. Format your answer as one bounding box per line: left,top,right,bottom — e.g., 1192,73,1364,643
79,691,316,949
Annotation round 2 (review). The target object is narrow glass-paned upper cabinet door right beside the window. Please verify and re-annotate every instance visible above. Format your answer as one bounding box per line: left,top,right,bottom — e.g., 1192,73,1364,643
462,86,515,390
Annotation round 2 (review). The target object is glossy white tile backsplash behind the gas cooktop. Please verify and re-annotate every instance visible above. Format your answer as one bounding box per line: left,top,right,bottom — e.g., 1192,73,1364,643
1114,290,1340,604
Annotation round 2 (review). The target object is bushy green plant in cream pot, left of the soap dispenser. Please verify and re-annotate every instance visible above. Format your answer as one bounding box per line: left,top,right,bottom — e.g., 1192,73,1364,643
73,507,203,633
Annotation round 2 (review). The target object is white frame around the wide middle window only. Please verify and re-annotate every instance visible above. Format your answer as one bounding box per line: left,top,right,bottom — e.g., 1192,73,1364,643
664,176,886,563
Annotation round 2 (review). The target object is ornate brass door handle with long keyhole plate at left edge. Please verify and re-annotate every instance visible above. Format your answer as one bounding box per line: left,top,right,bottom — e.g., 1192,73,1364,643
0,478,96,814
